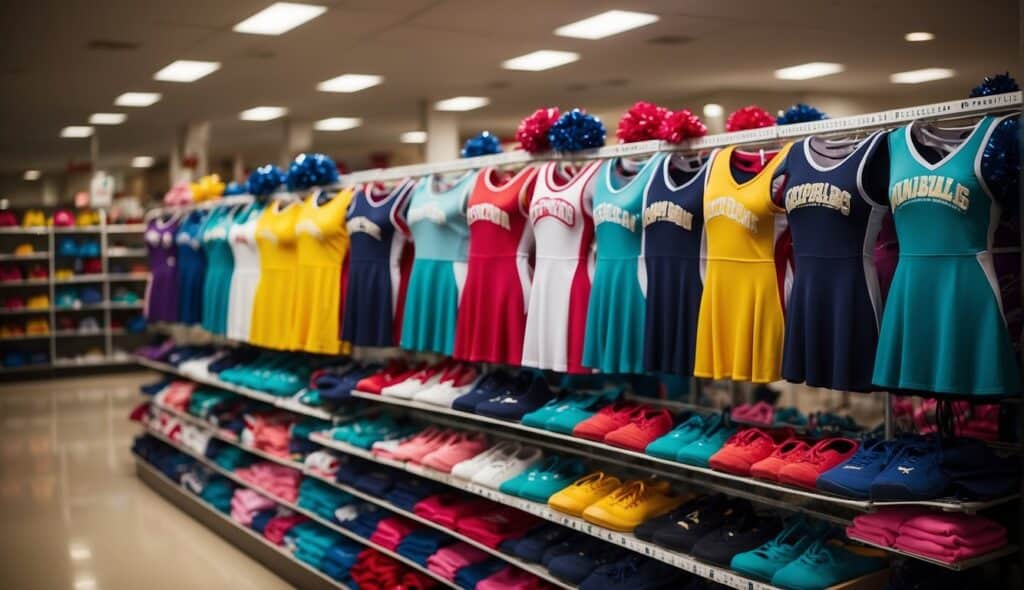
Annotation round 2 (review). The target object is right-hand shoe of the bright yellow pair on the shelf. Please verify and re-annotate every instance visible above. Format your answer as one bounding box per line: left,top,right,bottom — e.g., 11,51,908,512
583,479,686,533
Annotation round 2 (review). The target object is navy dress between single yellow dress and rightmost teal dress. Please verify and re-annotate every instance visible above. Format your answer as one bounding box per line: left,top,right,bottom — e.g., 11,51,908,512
775,133,888,391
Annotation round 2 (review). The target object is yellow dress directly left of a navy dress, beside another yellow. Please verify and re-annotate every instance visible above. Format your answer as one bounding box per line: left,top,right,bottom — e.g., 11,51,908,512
292,188,353,354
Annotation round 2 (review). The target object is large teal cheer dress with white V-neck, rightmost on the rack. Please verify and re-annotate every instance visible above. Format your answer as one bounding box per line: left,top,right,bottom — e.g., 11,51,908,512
873,117,1021,395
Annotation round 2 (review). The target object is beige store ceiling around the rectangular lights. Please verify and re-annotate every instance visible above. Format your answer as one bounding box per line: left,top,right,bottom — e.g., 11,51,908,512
0,0,1021,172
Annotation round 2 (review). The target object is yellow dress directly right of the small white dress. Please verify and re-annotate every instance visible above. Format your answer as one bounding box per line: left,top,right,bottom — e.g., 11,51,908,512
249,201,302,350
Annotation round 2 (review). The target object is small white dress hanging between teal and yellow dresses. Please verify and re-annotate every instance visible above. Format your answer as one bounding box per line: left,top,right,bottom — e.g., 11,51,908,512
227,203,262,341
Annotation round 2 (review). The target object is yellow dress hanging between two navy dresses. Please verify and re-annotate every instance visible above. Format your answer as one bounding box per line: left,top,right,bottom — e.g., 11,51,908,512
693,145,790,383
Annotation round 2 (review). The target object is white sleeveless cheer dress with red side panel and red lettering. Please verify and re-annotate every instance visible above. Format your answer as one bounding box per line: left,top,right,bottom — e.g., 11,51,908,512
522,162,600,373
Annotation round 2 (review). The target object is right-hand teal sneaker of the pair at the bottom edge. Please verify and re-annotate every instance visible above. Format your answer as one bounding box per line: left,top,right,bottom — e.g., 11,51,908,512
771,539,889,590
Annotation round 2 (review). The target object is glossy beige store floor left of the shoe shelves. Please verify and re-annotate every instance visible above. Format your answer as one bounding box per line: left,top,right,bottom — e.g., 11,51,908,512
0,373,289,590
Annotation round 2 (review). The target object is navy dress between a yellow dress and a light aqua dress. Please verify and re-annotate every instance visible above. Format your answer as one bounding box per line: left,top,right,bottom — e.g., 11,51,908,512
341,180,414,346
